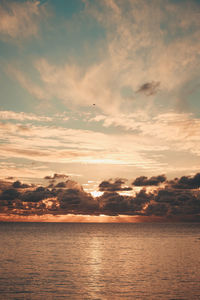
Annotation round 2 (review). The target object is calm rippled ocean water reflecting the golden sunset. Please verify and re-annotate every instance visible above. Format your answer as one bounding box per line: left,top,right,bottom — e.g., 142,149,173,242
0,223,200,300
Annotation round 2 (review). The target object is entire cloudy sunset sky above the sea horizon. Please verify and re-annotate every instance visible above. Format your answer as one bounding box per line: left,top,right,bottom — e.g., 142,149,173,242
0,0,200,221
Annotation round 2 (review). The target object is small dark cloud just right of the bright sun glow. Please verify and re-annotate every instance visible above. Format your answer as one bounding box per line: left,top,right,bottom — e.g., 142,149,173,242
99,178,132,192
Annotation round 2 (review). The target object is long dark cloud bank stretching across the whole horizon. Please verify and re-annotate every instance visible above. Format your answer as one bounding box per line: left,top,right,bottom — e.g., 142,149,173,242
0,173,200,221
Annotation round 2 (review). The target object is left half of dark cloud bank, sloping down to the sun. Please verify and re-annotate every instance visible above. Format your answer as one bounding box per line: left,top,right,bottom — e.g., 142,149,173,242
0,178,98,215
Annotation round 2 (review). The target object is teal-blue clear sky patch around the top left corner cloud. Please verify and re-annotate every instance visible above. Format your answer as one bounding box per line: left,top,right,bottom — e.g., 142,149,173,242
0,0,105,89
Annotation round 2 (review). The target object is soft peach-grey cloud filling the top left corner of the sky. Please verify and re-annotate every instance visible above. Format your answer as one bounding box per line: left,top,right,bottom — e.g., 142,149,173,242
0,1,48,39
